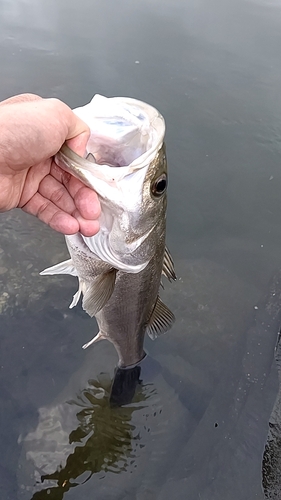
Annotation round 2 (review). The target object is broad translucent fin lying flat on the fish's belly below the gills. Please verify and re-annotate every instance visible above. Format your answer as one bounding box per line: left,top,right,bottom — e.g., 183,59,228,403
82,269,116,318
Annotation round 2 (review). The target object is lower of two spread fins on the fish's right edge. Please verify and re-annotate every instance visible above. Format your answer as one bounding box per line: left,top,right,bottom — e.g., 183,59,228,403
146,297,175,340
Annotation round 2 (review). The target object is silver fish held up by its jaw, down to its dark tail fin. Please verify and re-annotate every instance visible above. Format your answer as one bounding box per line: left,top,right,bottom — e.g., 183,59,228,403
41,95,176,368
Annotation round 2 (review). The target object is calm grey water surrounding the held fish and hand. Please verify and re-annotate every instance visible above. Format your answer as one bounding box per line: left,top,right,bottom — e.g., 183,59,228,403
0,0,281,500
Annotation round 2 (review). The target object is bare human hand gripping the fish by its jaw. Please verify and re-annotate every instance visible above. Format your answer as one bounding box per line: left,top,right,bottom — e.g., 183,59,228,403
0,94,100,236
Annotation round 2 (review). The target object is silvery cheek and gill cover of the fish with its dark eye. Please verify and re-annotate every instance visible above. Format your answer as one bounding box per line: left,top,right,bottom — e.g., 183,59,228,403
101,144,167,266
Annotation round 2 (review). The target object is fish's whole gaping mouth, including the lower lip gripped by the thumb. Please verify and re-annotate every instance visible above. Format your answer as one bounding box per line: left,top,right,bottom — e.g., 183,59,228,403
55,95,165,192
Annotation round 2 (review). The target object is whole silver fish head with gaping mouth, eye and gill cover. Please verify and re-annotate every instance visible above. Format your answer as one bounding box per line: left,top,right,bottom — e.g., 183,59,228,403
56,96,167,273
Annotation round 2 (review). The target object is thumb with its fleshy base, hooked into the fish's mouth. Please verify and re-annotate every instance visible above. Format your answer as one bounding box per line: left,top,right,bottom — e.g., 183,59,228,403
0,98,90,171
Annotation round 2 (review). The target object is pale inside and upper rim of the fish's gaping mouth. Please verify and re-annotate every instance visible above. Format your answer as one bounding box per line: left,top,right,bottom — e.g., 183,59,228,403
74,94,165,168
